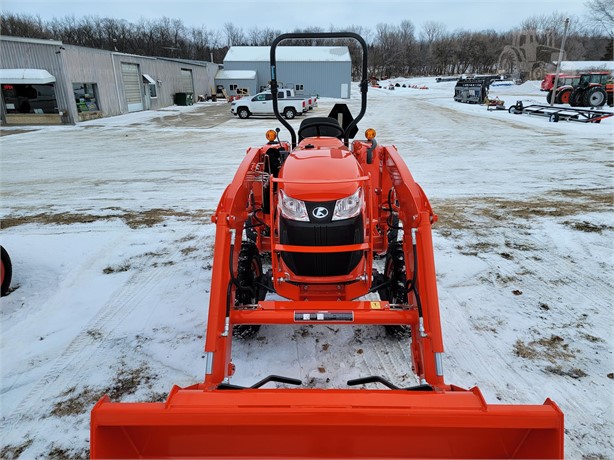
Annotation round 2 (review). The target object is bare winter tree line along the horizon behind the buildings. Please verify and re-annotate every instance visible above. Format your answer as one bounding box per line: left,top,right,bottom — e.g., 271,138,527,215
0,6,614,78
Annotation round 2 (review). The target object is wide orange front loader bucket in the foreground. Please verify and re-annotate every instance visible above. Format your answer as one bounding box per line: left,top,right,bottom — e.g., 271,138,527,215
91,386,563,459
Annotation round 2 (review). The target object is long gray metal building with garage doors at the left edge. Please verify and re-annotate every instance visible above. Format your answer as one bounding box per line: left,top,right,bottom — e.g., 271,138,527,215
0,36,218,124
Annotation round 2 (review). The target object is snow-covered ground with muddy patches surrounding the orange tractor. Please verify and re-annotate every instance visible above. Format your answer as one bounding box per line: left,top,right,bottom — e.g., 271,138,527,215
0,79,614,459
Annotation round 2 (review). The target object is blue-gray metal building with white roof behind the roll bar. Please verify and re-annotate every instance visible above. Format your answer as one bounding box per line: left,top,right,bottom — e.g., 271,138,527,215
224,46,352,98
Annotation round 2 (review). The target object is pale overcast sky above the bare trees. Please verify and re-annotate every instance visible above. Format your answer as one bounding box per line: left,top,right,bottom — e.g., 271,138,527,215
0,0,586,32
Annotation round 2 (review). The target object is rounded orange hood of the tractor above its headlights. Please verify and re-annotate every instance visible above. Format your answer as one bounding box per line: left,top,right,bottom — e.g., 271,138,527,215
279,137,363,201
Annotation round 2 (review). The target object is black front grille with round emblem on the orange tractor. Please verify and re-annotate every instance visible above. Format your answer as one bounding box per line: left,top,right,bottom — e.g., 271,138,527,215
279,213,364,276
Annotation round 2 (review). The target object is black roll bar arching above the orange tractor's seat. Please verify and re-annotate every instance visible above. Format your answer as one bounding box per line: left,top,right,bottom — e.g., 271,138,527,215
271,32,369,148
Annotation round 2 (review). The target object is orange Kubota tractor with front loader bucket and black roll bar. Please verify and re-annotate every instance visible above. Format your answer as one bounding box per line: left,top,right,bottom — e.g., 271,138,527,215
90,33,564,459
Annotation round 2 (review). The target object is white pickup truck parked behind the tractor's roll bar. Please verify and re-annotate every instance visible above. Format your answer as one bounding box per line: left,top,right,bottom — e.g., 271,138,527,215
230,89,309,119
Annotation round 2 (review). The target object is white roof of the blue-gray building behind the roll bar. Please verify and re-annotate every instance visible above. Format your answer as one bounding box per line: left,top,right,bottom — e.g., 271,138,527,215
224,46,351,62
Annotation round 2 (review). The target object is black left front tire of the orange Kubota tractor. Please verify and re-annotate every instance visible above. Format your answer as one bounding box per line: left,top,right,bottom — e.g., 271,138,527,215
232,241,266,339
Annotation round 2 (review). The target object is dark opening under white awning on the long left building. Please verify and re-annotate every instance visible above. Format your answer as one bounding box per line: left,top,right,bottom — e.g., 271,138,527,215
2,83,58,114
